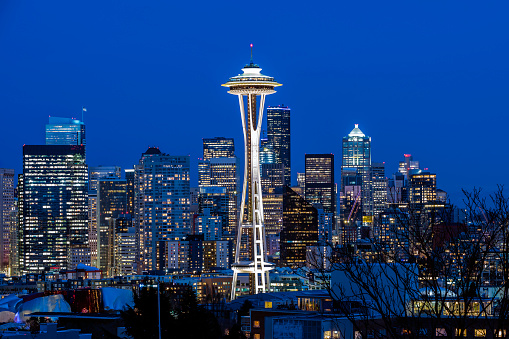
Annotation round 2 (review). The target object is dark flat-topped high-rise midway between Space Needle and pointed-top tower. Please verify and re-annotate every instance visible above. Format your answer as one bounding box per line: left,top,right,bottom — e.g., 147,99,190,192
305,154,336,225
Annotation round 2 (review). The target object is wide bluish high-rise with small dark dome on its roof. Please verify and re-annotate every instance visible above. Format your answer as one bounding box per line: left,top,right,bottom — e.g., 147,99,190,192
135,147,191,271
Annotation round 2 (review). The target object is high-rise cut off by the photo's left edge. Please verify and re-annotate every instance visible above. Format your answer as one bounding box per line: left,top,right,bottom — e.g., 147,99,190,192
0,168,16,272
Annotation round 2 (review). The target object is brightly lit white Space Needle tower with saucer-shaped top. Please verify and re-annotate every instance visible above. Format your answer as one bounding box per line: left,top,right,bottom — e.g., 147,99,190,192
222,45,281,300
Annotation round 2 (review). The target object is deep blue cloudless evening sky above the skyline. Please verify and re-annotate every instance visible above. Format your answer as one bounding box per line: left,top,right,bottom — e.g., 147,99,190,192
0,0,509,205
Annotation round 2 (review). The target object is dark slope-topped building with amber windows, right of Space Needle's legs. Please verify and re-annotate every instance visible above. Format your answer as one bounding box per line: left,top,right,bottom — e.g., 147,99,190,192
280,186,318,267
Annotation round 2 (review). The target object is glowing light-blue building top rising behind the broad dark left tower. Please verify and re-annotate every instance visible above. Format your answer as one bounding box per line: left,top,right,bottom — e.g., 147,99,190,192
46,117,86,146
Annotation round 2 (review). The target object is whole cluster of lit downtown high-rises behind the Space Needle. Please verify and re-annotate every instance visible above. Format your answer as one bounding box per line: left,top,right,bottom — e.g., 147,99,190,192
0,109,447,277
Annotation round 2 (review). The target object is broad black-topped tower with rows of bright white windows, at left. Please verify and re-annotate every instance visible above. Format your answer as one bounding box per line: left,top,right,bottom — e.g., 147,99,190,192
20,145,90,273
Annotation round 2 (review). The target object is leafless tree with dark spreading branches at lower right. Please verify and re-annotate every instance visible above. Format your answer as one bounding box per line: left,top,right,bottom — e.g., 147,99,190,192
309,187,509,338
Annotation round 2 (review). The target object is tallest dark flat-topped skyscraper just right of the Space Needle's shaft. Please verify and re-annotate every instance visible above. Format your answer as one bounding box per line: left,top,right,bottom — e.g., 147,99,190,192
267,105,292,186
